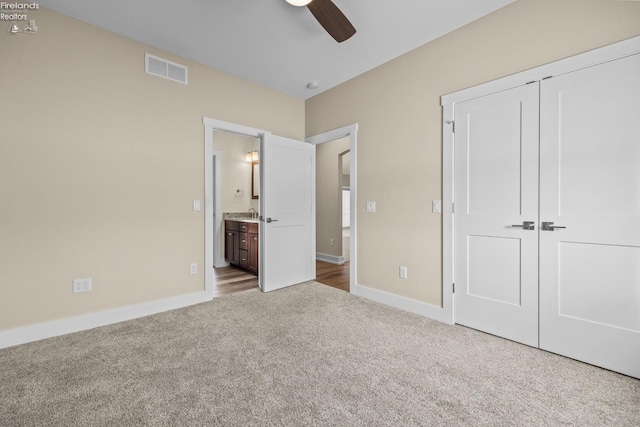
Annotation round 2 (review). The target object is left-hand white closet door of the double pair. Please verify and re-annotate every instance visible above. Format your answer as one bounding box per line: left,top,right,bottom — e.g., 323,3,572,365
454,83,539,347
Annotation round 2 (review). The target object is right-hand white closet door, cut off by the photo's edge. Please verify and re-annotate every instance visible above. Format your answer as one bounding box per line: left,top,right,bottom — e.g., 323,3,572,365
540,55,640,377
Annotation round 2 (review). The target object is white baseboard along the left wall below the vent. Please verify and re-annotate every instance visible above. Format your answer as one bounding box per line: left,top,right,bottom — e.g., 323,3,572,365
0,292,212,348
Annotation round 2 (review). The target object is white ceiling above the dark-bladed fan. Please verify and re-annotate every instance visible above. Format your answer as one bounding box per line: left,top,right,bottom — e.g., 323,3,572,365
41,0,515,99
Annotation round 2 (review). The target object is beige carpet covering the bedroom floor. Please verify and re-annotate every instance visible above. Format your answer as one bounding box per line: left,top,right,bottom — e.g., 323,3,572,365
0,282,640,426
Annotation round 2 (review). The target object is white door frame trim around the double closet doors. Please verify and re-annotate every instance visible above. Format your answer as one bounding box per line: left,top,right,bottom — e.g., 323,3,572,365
440,36,640,324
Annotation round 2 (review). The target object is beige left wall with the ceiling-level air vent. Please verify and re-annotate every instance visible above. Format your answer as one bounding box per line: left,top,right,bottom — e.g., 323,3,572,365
0,8,304,330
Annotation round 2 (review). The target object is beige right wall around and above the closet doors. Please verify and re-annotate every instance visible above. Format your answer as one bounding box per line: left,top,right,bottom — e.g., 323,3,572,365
306,0,640,306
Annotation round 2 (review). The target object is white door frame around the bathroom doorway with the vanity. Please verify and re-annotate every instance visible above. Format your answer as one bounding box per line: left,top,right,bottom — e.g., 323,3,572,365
202,117,271,298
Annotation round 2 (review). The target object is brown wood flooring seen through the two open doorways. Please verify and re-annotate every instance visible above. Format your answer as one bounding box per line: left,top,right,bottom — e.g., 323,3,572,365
213,261,349,298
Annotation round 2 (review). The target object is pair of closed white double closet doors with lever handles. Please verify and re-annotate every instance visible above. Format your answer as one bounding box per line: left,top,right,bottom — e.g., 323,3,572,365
454,55,640,378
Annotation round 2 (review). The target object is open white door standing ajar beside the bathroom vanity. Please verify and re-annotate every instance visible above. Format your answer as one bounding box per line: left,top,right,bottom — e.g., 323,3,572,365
260,135,316,292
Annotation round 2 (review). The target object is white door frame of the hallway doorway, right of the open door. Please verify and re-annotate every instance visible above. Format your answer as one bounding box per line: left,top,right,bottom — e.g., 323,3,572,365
305,123,358,293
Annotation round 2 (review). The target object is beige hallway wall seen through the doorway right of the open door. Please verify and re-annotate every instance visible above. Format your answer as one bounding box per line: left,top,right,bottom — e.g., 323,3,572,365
316,138,350,257
